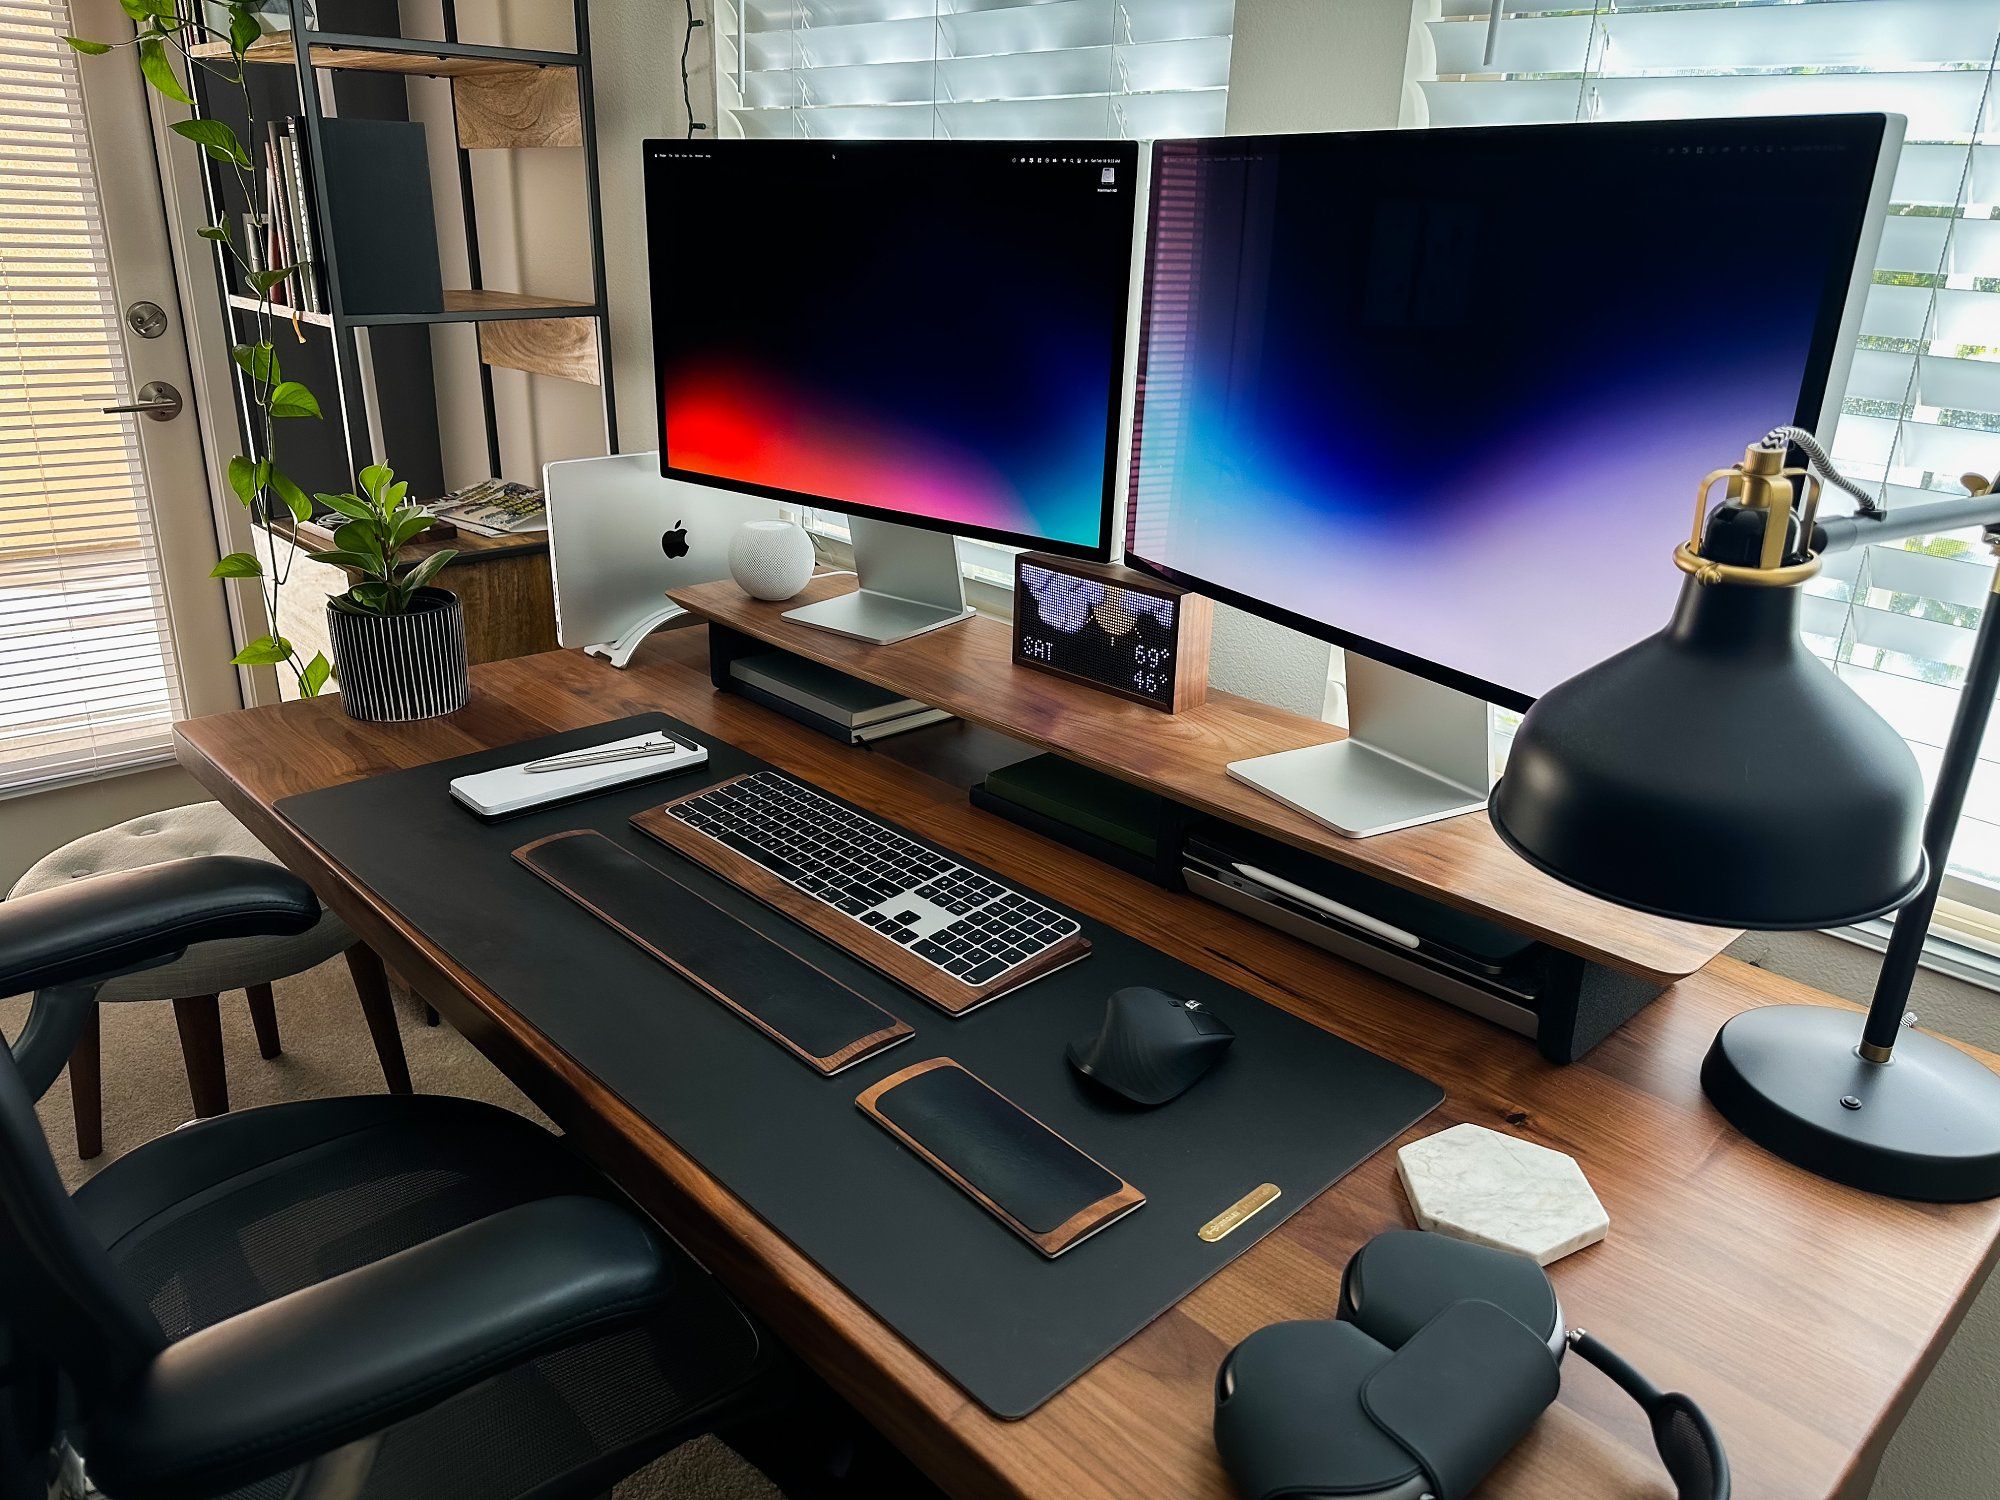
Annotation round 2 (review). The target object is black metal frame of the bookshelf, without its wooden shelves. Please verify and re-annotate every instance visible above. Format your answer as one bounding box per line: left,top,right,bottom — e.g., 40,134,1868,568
186,0,618,490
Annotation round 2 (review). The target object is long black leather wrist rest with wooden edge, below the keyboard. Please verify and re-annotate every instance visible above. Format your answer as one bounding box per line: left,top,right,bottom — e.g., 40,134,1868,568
514,830,916,1074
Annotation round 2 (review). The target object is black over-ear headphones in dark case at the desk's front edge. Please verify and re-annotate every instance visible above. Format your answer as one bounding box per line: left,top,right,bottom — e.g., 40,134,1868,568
1216,1230,1730,1500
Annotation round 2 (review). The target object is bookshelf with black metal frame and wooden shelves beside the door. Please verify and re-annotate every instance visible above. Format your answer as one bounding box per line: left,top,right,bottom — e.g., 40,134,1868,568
194,0,618,492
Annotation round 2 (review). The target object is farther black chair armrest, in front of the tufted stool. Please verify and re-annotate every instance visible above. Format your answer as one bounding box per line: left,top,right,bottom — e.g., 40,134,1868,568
0,854,320,996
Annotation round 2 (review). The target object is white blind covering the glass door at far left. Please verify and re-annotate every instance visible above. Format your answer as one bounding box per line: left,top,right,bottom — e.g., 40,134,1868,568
0,0,180,796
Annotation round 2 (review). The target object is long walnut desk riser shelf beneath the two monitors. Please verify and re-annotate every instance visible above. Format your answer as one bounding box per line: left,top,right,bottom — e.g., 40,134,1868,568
668,578,1736,982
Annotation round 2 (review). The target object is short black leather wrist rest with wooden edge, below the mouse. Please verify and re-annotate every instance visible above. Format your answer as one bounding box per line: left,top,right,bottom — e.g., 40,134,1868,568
854,1058,1146,1258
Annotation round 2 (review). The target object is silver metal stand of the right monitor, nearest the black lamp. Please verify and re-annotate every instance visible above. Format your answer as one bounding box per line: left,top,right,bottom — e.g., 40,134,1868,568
1228,652,1492,838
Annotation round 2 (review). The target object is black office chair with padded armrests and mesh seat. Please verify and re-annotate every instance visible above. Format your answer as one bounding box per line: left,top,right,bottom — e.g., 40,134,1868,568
0,856,776,1500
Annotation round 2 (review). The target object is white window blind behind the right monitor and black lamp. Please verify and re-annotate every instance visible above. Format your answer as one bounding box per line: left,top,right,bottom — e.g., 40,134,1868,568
1420,0,2000,906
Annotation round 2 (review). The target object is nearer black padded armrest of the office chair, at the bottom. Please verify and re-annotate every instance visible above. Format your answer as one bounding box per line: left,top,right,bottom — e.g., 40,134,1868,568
84,1196,680,1496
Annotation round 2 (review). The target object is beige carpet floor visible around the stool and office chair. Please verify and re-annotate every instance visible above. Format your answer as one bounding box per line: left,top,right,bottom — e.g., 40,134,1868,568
0,958,782,1500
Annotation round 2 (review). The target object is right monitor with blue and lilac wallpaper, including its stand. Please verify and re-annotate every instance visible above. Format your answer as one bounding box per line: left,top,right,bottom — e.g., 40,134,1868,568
1126,114,1902,832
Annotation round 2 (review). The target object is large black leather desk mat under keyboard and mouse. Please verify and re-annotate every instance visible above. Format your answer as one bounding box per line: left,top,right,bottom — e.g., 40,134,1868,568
278,714,1444,1418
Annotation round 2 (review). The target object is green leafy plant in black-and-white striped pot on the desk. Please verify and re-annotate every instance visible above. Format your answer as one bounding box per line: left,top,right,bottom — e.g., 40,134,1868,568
308,464,470,722
